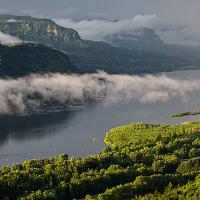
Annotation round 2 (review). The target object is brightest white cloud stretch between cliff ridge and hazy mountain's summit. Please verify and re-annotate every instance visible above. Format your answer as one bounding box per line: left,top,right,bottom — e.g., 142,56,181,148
54,15,157,41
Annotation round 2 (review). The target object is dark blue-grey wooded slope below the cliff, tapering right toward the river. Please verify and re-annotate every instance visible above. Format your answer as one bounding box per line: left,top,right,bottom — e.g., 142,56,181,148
70,41,188,74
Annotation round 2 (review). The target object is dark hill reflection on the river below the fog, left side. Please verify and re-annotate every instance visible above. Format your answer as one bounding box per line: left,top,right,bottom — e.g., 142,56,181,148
0,111,76,145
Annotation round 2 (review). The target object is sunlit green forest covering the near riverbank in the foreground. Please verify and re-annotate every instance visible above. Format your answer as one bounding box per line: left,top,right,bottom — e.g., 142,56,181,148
0,121,200,200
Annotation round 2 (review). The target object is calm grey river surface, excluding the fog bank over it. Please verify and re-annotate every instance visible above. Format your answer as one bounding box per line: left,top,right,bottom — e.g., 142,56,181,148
0,71,200,165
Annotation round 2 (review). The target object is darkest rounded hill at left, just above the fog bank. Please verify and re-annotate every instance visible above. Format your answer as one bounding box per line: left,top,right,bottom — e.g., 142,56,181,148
0,44,79,77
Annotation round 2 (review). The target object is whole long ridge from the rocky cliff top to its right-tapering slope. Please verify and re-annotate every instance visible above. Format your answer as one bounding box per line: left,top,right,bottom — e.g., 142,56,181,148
0,15,188,73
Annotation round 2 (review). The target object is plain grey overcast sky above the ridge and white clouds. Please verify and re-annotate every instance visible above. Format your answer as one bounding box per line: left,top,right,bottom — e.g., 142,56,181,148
0,0,200,22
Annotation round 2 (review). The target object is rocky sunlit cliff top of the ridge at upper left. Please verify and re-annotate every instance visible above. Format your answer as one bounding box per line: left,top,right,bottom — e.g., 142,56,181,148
0,15,86,49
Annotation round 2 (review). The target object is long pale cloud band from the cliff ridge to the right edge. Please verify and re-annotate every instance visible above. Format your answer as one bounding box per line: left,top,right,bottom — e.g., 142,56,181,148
54,14,200,46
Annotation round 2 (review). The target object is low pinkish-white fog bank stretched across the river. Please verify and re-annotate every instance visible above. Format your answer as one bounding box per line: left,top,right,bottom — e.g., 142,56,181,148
0,72,200,114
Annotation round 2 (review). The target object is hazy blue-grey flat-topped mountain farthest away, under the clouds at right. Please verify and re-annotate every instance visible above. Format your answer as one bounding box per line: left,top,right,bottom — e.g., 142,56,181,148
105,28,200,65
